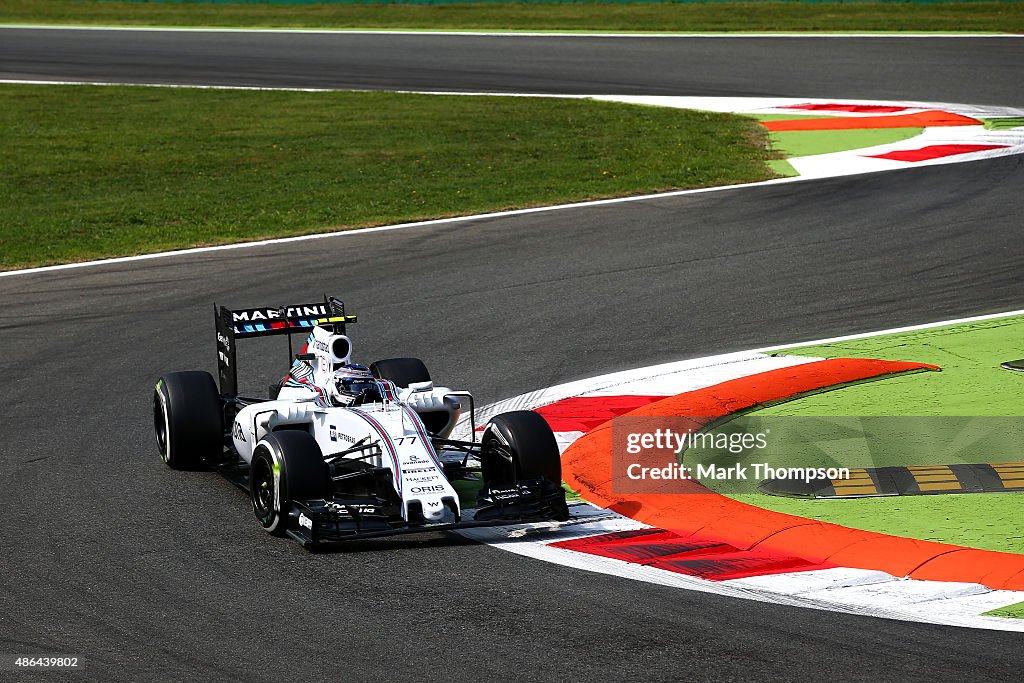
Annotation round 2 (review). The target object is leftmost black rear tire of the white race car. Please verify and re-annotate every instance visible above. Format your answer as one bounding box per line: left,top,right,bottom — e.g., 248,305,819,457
153,372,224,470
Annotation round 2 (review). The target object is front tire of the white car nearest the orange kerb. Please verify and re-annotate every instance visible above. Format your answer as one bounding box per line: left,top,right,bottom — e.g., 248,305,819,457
480,411,562,488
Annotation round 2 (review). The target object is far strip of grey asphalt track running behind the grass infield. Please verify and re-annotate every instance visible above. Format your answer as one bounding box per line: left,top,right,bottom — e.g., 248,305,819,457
0,29,1024,106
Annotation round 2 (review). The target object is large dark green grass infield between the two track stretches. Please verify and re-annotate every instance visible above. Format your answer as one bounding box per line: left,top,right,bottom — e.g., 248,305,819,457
0,85,772,268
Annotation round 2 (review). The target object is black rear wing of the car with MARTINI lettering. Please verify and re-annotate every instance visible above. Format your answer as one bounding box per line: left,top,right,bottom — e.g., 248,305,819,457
213,295,356,396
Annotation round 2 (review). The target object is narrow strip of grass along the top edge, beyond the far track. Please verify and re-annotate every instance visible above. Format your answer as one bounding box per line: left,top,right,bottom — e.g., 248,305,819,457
0,0,1024,33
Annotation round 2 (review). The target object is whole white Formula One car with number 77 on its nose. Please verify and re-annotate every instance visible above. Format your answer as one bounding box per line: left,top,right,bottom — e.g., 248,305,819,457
153,297,568,547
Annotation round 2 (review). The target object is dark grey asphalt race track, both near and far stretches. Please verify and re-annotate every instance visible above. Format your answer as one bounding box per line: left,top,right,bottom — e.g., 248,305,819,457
0,30,1024,681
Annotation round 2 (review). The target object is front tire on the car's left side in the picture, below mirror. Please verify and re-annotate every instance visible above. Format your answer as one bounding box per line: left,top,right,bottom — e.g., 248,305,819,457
249,429,328,536
